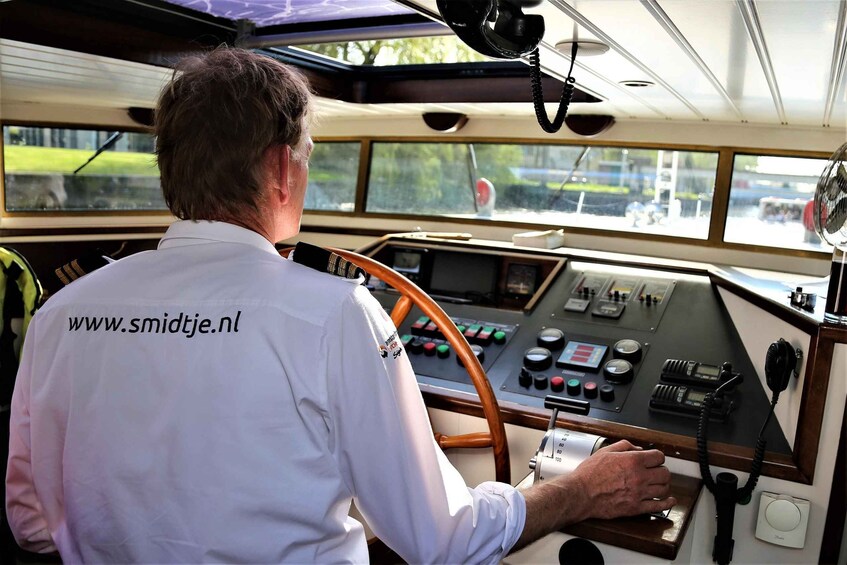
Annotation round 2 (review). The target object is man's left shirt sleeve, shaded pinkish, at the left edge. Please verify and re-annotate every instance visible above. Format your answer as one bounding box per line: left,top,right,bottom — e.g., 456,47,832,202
6,318,57,553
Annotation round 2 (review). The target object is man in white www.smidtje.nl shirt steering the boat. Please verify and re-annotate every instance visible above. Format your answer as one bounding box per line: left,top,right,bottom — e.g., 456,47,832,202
6,49,675,563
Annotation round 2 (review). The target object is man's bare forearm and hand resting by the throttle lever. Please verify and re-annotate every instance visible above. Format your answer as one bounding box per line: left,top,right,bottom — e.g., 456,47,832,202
513,440,676,549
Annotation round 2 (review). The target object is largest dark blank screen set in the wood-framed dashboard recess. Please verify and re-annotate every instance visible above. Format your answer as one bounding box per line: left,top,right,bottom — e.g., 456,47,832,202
429,251,498,298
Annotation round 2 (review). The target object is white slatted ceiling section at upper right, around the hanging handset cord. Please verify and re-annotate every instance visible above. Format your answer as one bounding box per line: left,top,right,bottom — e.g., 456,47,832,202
404,0,846,127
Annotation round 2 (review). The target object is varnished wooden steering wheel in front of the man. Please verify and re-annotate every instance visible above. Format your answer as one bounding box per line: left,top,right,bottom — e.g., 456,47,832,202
280,247,511,483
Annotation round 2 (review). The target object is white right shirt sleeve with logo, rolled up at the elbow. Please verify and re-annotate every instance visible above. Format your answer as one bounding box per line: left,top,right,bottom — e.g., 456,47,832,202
327,287,526,563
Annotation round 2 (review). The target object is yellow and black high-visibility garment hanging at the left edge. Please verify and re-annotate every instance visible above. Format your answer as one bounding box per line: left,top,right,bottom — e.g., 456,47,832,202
0,247,44,412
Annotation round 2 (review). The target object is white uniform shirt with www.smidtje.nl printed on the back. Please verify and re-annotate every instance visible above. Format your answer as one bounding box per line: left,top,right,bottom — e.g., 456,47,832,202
6,222,525,563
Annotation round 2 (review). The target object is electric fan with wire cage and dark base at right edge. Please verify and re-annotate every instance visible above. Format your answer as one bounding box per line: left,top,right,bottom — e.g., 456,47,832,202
814,143,847,324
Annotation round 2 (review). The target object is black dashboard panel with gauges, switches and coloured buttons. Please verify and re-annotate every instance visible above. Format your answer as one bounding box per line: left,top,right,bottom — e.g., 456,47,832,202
371,242,791,455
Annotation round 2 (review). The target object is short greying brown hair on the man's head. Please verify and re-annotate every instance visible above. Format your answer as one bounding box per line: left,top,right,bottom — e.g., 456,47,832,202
155,48,312,220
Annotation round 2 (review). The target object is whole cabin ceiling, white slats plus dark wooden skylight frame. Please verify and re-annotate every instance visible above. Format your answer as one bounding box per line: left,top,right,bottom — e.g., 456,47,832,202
0,0,847,129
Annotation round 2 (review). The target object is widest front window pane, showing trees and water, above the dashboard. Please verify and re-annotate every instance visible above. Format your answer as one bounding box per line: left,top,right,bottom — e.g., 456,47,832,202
366,142,717,239
